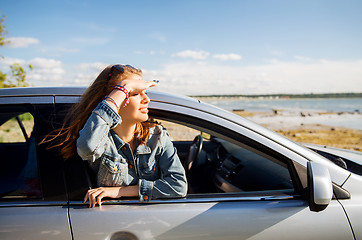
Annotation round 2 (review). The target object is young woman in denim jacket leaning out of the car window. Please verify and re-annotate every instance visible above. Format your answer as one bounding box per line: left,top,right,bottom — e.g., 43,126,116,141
57,65,187,207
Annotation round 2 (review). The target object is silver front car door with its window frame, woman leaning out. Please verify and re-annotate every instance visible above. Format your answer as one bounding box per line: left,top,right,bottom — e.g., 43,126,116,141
69,112,353,239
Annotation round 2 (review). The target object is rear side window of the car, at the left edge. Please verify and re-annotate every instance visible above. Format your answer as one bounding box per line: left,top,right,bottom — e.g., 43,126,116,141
0,107,41,200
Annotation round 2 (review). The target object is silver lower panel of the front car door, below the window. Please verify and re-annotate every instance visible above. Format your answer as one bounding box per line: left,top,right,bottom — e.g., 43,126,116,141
70,197,353,239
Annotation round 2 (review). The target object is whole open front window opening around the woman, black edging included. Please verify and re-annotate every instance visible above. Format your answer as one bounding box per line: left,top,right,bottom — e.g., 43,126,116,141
65,107,300,202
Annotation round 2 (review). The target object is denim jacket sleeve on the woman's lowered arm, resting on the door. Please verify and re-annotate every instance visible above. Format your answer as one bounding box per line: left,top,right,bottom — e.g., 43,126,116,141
139,126,187,202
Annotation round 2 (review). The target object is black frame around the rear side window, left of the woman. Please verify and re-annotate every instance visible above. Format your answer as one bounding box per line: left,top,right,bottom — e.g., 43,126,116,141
0,100,68,203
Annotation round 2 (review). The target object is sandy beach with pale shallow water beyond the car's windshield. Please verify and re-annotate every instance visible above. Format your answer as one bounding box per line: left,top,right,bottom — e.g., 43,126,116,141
233,111,362,152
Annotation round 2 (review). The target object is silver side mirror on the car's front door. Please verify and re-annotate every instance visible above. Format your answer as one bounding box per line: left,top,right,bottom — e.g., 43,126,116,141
307,162,333,212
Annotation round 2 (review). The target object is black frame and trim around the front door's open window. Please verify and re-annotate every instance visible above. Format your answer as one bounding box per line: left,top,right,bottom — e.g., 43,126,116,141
65,109,305,204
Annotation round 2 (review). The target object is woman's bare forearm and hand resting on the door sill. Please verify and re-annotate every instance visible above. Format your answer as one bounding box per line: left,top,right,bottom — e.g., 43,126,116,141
84,185,138,208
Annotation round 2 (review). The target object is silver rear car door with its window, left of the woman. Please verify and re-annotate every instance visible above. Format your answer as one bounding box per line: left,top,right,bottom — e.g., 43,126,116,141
0,102,71,239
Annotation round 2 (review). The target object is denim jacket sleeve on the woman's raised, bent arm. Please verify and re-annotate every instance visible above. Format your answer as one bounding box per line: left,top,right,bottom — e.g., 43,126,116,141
77,100,121,162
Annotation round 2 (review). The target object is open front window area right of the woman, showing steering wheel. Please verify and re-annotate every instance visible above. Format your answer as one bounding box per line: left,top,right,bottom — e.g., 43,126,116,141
152,119,294,194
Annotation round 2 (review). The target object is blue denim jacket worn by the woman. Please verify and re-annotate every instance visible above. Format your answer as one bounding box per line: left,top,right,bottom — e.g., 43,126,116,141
77,101,187,202
